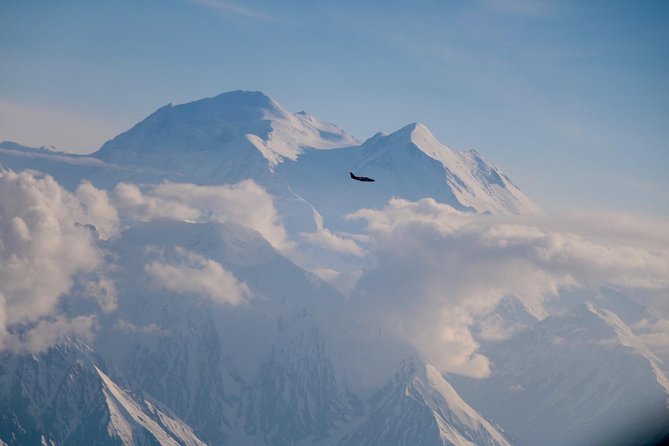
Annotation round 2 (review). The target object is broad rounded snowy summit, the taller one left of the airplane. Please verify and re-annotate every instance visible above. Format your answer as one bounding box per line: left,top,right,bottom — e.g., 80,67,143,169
95,91,358,167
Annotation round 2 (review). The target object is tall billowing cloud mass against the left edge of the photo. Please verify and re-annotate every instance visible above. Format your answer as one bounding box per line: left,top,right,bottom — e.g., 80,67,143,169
0,171,102,351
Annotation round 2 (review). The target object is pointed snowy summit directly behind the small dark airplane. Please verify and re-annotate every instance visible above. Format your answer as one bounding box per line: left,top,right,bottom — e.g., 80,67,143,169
277,124,538,228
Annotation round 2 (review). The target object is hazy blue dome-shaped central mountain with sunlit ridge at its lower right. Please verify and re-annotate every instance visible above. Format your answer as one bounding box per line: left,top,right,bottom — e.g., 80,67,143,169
75,221,506,445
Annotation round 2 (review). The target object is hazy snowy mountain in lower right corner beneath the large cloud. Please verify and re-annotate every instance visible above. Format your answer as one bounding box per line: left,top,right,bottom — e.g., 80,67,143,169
454,303,669,446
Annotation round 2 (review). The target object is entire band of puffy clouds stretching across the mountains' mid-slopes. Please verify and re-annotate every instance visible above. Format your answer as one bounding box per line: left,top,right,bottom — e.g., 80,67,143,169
0,167,669,377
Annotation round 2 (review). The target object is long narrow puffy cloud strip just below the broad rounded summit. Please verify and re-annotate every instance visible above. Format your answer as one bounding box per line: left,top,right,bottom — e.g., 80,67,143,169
112,180,292,250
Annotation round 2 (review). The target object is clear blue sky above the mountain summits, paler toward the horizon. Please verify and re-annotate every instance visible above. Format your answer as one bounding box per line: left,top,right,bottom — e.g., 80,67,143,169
0,0,669,216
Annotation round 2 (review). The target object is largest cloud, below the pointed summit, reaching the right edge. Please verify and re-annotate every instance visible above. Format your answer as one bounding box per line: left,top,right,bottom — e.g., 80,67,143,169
348,199,669,377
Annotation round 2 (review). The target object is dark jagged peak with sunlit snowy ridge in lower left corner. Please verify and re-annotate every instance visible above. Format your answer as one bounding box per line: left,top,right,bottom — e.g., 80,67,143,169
0,340,204,446
